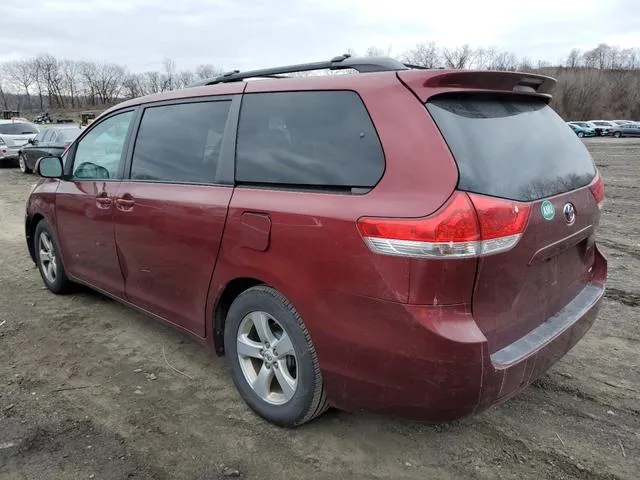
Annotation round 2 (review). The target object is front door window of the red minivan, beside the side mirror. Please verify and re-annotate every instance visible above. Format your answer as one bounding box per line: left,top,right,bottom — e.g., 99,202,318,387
73,111,133,180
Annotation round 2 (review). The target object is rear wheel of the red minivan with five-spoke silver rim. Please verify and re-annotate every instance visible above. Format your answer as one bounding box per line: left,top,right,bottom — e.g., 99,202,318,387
224,285,329,427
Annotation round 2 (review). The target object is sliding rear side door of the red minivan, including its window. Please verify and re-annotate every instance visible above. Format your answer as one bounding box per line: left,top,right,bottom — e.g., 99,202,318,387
115,96,240,337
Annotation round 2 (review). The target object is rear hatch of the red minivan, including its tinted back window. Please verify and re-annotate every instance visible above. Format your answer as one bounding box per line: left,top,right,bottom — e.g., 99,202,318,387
426,92,600,353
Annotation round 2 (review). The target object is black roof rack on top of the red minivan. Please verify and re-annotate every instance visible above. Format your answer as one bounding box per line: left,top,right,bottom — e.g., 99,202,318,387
189,53,413,87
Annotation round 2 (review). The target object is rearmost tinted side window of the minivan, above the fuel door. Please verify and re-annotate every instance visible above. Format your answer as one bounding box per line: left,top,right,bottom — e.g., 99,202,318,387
236,91,384,187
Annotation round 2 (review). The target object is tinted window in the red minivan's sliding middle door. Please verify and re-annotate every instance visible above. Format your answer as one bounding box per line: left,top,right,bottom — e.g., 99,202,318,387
131,101,231,183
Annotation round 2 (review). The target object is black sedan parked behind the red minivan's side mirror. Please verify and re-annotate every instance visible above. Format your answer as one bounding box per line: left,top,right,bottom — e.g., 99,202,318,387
18,125,82,173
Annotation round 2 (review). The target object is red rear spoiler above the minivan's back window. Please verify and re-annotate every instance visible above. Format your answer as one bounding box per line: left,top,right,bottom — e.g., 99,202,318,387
397,70,557,102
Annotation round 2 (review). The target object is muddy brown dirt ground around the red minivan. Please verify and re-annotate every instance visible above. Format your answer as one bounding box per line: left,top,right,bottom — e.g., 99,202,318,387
0,139,640,480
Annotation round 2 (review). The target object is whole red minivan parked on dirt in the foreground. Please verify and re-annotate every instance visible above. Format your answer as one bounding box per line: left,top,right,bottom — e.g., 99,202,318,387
26,55,607,426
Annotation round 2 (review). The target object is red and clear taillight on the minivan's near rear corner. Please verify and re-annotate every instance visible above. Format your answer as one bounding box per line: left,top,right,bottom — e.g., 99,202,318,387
358,191,530,258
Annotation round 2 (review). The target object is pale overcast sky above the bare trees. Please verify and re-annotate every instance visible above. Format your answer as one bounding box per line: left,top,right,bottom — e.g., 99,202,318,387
0,0,640,71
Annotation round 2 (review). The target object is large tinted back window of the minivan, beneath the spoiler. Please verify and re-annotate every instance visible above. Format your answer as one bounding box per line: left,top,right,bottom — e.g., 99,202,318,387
427,96,595,201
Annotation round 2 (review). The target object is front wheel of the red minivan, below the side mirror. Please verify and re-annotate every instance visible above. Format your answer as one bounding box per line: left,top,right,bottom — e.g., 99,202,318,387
33,220,71,295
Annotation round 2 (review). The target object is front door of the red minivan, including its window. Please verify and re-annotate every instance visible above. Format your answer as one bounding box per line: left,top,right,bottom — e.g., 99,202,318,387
56,110,134,297
